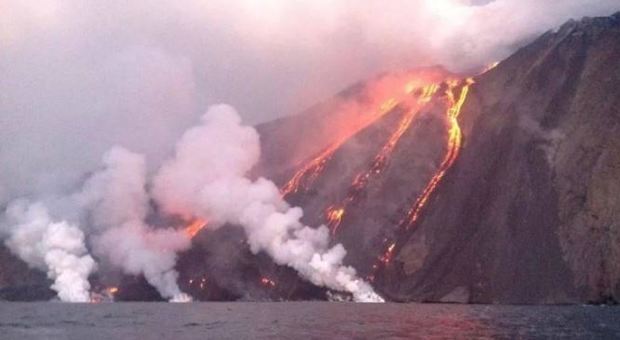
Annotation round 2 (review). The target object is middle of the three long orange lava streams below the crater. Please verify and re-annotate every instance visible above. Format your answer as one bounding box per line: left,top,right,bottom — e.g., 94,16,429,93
325,84,439,234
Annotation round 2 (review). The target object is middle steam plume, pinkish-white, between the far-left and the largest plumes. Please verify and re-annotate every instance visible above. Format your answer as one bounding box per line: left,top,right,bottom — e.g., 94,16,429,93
75,147,190,301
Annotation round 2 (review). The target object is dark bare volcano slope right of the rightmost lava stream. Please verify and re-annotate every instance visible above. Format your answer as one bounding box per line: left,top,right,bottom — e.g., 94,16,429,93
383,14,620,303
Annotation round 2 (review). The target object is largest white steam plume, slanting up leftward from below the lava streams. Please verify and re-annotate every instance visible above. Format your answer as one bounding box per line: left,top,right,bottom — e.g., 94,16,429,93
153,105,382,302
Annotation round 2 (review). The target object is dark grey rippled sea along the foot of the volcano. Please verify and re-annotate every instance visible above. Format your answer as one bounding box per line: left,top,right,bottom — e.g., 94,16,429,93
0,302,620,340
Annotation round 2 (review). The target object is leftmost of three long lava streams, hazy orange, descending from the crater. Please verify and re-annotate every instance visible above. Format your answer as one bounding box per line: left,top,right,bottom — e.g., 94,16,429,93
280,98,398,196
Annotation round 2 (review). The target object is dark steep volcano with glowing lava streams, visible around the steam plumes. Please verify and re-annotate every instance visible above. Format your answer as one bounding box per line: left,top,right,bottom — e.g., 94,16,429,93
0,13,620,304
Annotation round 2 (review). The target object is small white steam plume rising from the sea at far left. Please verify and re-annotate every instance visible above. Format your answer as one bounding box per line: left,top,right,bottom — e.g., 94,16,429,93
3,200,96,302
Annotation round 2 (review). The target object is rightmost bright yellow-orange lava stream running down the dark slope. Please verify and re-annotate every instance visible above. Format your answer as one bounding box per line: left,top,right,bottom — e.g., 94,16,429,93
371,78,474,268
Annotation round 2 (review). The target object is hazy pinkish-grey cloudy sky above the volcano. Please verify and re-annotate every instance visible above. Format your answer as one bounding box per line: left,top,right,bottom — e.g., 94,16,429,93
0,0,620,203
